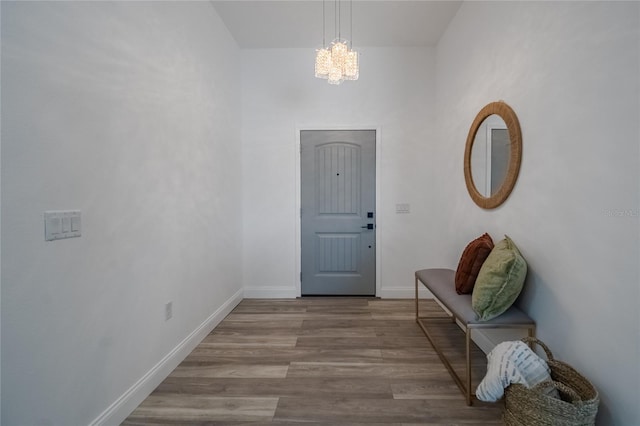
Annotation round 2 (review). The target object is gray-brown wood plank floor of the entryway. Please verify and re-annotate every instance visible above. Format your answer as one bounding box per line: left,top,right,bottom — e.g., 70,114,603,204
123,298,503,426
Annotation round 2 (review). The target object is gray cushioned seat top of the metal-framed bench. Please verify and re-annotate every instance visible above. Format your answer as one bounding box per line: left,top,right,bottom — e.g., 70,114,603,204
415,268,534,326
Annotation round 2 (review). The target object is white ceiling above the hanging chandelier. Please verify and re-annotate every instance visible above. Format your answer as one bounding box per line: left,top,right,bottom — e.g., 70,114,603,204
211,0,462,49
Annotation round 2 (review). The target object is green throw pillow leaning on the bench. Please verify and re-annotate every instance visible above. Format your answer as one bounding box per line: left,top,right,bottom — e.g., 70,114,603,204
471,235,527,321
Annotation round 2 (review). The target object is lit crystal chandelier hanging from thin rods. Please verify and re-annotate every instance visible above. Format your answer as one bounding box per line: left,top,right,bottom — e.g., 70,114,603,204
315,0,360,84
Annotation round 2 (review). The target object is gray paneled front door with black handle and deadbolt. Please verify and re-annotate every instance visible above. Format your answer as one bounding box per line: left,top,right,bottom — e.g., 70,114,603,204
300,130,376,296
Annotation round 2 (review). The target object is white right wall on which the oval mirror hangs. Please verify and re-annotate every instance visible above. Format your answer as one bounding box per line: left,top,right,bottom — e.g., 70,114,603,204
432,2,640,426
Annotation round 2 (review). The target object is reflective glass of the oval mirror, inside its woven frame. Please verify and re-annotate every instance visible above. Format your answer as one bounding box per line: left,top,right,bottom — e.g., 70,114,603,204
471,114,511,197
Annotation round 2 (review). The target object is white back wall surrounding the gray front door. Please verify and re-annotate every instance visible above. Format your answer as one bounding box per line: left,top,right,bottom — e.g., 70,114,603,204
242,46,438,297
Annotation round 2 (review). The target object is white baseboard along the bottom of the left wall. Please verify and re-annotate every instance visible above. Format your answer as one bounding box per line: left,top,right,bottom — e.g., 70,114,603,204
90,289,243,426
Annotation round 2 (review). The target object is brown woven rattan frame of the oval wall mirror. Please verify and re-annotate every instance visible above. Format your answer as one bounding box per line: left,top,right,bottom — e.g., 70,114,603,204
464,101,522,209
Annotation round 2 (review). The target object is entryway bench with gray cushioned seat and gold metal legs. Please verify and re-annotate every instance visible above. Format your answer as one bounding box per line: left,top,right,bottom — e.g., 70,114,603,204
415,269,536,405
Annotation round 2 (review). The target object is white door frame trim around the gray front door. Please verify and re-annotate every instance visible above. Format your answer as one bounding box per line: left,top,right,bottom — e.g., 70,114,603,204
293,124,384,297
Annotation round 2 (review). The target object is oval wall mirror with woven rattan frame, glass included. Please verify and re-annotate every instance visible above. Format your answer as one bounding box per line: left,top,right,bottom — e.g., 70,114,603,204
464,101,522,209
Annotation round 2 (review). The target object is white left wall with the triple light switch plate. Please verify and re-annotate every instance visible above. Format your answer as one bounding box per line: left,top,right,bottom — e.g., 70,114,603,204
1,2,242,425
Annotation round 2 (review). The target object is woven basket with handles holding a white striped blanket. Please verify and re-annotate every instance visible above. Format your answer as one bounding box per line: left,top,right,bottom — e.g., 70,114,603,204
504,337,600,426
